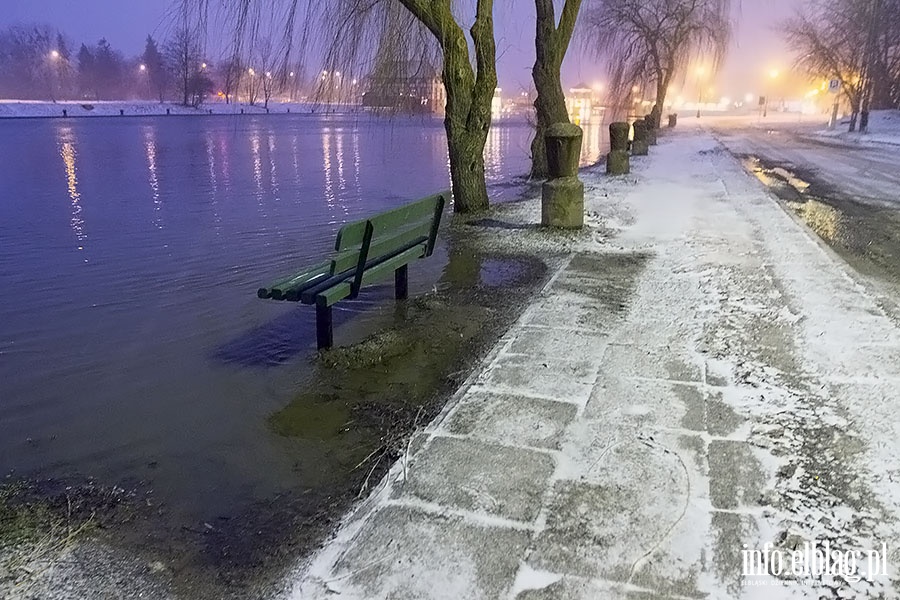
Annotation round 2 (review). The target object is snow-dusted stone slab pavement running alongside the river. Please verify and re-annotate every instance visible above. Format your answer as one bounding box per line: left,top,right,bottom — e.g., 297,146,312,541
282,132,900,600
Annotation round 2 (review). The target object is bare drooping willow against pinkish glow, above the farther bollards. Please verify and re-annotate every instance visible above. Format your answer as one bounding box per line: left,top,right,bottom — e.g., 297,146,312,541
582,0,731,125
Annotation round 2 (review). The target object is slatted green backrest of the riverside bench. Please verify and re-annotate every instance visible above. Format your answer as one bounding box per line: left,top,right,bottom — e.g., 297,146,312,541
332,192,450,274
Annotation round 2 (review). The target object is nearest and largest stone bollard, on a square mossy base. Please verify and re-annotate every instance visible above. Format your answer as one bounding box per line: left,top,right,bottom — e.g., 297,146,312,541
541,123,584,229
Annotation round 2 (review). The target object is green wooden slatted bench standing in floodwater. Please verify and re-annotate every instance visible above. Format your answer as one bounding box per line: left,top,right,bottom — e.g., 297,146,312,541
256,192,450,349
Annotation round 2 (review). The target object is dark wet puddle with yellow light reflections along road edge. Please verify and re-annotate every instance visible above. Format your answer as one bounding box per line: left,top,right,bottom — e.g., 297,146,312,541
742,156,900,285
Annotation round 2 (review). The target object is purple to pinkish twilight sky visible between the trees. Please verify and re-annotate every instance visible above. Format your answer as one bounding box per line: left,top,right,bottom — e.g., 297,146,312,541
0,0,800,96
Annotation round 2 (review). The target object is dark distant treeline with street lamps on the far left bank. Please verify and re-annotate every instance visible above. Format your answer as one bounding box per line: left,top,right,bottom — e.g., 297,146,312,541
0,25,310,106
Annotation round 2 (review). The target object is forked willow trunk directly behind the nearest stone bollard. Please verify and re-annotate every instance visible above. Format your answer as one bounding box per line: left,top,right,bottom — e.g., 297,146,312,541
531,0,582,178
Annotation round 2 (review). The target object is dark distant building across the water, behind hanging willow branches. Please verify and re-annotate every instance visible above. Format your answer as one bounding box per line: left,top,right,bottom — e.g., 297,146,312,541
362,64,447,116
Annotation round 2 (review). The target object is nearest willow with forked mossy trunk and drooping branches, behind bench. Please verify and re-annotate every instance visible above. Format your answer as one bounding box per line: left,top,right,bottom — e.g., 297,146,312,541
205,0,497,212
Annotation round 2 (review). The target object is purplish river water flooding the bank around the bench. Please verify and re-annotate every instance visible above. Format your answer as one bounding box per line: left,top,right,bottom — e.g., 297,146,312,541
0,115,605,521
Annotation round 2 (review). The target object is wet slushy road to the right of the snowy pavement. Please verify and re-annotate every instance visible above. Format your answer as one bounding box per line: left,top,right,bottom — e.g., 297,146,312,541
712,123,900,290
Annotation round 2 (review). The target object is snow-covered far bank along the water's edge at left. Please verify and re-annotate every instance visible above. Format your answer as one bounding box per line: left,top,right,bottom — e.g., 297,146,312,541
0,100,338,119
